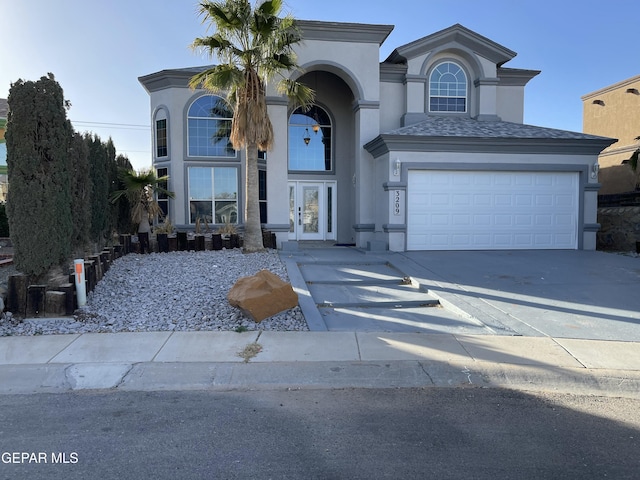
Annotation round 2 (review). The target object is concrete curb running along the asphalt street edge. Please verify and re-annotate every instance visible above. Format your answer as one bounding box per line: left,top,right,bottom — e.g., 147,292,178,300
0,360,640,399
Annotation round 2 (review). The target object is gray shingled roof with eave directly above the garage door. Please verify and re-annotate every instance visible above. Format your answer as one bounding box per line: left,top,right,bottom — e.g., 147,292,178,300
364,115,616,157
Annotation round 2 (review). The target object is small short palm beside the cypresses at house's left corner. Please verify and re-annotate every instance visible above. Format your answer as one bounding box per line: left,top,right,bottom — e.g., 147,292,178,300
110,168,175,233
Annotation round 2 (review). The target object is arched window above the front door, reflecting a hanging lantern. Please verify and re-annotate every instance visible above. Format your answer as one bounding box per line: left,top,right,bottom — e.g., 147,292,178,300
289,105,333,172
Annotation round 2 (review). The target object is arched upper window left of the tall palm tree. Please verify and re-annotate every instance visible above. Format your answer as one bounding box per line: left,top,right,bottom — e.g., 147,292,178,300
187,95,236,157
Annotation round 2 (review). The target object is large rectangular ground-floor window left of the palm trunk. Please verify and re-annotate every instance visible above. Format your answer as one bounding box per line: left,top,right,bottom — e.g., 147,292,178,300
189,167,238,224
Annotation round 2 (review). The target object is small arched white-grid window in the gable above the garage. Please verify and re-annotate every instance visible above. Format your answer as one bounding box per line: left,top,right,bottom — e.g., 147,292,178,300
429,62,467,112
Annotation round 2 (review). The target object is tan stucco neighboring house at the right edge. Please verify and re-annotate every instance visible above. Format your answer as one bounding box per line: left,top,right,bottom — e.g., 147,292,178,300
582,75,640,194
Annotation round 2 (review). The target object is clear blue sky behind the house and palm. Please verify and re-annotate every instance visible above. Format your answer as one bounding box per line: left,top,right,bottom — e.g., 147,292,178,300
0,0,640,168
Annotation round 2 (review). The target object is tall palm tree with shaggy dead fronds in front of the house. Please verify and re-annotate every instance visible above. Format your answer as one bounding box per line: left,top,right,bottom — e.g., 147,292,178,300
189,0,313,253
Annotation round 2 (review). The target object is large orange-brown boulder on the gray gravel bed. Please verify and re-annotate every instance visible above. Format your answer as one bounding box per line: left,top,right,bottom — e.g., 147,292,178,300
227,270,298,322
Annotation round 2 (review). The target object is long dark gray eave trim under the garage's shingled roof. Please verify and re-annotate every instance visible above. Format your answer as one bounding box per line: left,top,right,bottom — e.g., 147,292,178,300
364,134,610,158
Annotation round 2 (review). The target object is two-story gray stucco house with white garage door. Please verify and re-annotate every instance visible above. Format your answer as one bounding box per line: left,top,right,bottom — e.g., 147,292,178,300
139,21,613,251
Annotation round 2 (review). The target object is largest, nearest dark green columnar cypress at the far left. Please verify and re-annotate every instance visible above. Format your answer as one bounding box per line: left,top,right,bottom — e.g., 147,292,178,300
5,74,73,279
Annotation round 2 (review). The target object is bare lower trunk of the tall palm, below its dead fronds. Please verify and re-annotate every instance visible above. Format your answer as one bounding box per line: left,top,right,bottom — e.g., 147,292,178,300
244,143,264,253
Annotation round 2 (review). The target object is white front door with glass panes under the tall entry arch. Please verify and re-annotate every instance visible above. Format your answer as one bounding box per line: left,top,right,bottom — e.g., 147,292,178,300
289,181,336,240
